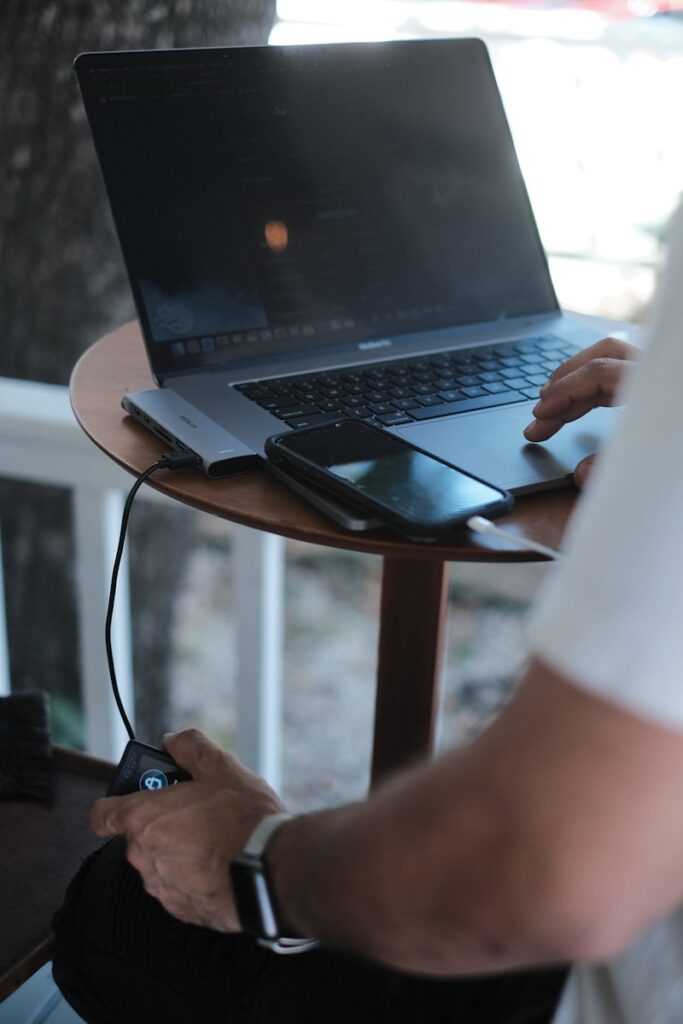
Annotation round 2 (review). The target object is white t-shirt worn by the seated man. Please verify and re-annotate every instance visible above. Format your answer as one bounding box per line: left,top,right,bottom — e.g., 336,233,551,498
529,199,683,1024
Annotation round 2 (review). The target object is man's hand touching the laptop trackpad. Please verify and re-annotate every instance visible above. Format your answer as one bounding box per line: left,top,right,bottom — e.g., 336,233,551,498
524,338,638,486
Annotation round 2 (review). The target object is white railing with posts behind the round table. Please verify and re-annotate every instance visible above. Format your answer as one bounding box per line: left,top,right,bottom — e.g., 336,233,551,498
0,378,284,786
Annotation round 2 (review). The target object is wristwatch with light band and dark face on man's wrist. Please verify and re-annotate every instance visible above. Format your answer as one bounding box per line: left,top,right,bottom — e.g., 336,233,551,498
230,814,319,953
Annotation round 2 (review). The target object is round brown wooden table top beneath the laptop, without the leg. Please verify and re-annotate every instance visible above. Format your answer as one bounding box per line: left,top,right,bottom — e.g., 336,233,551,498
71,323,575,562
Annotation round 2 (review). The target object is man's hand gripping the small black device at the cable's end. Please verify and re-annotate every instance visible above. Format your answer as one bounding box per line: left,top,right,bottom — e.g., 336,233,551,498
90,729,284,932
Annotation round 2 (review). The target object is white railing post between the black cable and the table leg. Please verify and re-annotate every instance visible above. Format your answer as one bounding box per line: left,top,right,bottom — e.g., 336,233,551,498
233,526,285,790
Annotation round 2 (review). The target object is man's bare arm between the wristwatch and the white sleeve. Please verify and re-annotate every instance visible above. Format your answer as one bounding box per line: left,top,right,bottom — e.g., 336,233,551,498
267,662,683,974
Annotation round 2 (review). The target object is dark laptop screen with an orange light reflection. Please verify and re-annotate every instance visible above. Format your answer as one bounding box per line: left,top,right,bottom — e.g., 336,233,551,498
76,40,556,377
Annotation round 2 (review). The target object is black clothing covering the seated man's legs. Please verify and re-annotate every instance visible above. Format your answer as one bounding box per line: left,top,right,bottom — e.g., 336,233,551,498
53,837,566,1024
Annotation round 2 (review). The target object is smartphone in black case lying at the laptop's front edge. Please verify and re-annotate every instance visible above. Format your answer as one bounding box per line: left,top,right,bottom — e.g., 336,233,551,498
265,420,512,541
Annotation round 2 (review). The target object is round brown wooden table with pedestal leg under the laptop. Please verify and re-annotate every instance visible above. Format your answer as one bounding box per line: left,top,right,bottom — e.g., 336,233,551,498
71,324,574,784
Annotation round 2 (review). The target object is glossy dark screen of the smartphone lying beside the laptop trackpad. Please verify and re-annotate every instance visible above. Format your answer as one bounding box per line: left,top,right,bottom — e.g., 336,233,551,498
280,421,502,524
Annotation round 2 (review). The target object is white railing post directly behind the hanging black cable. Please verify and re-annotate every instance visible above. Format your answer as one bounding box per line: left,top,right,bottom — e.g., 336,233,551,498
74,486,134,761
